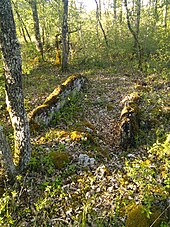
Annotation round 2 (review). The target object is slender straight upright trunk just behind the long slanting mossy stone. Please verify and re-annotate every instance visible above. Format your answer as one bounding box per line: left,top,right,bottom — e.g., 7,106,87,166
62,0,69,71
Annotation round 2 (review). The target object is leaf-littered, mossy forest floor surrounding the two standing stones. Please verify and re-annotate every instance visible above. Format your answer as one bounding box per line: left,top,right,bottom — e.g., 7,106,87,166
0,64,170,227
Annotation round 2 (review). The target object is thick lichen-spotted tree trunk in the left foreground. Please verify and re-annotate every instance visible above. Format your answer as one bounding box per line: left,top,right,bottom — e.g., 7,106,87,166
0,0,31,170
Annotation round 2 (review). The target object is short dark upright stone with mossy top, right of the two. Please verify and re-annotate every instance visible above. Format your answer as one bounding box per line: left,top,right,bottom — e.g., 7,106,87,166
120,93,140,149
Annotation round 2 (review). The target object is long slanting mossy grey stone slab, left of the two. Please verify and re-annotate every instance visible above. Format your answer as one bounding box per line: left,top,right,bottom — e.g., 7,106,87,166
29,75,87,128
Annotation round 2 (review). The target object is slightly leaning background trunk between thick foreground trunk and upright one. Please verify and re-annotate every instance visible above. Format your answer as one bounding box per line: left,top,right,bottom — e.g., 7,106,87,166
30,0,43,58
